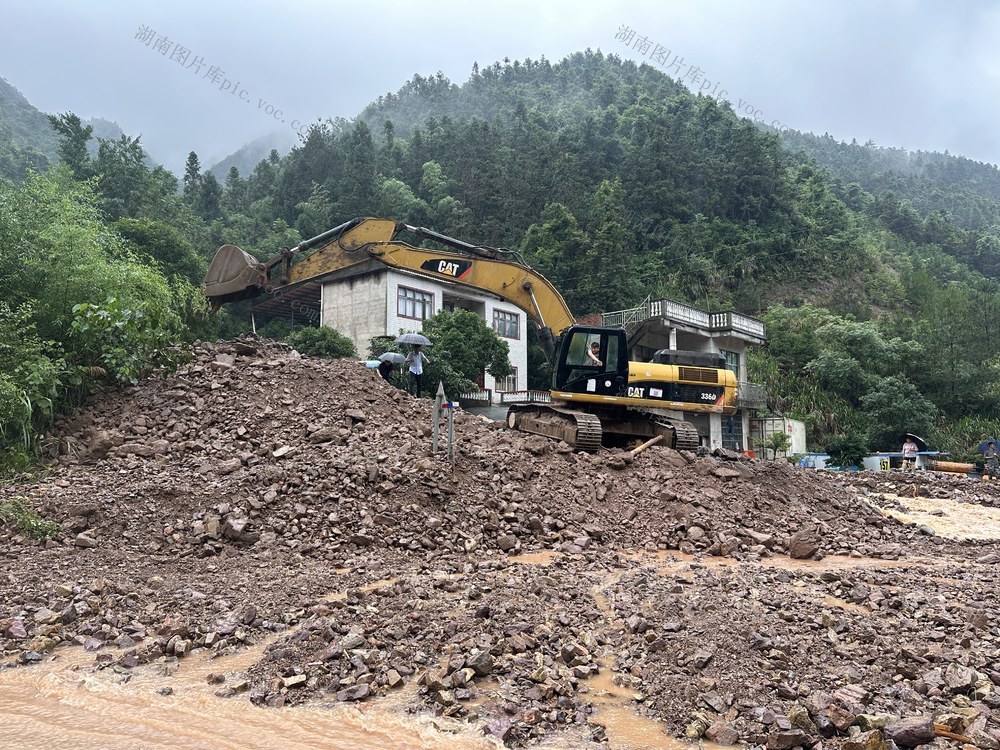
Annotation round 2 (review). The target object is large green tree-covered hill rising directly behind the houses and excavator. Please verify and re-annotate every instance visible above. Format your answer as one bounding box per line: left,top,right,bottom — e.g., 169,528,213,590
0,51,1000,464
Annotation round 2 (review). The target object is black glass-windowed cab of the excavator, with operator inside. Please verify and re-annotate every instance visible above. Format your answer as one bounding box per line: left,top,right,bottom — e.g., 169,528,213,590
552,325,628,396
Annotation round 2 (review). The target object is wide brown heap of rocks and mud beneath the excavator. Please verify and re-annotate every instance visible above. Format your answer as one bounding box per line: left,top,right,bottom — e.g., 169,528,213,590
0,339,1000,750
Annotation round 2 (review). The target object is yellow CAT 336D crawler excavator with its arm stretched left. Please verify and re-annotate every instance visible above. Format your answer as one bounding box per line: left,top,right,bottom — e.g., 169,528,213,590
204,217,736,451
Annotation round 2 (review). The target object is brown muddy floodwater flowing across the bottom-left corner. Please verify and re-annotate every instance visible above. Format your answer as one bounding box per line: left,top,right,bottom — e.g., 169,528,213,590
0,651,497,750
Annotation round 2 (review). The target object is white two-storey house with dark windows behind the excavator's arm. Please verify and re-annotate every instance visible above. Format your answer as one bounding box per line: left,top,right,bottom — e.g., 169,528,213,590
253,261,528,399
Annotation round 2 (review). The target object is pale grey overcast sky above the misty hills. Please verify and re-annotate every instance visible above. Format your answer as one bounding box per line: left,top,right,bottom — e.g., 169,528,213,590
0,0,1000,174
